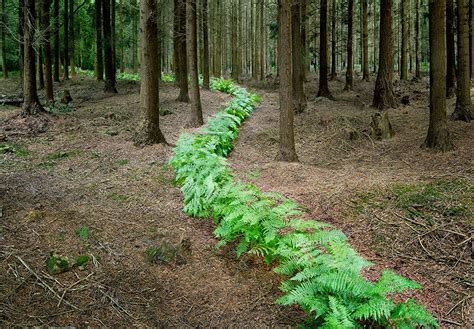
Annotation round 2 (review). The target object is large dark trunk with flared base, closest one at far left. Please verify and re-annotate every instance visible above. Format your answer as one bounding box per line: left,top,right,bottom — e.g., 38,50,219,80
23,0,44,115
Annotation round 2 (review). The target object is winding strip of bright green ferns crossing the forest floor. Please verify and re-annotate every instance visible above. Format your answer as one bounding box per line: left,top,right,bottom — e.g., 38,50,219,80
170,79,438,328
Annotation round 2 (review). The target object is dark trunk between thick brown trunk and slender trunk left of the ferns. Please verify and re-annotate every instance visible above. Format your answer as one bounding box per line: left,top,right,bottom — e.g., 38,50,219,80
175,0,189,103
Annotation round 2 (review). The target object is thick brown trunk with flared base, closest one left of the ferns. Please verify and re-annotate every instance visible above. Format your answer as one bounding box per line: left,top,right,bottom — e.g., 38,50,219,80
134,0,166,144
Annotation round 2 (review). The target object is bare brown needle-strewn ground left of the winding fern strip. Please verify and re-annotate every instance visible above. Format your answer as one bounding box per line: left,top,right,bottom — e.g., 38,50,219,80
0,79,302,328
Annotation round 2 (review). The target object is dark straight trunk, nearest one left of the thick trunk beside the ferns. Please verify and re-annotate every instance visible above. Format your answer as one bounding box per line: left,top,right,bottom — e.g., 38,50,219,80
102,0,117,93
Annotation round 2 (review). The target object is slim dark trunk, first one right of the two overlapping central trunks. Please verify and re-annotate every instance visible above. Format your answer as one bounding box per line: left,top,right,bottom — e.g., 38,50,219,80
318,0,333,99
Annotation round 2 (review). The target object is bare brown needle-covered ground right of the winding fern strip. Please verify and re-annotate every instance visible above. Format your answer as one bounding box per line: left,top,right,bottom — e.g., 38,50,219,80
229,76,474,327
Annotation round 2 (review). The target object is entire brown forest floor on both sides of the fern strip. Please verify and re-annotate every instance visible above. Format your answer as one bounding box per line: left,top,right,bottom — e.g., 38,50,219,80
0,74,474,327
